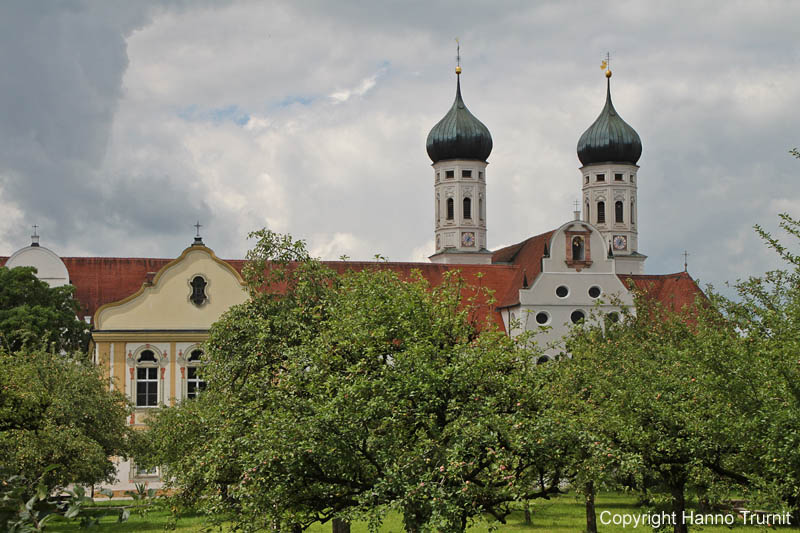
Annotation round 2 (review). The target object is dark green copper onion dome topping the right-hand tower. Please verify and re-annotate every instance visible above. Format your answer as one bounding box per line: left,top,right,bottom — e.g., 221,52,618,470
578,70,642,165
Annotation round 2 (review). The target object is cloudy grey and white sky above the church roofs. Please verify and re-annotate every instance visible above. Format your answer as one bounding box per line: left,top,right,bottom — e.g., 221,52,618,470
0,0,800,290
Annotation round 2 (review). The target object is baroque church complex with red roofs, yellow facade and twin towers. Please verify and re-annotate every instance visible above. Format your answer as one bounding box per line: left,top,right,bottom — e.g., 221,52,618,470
0,61,700,491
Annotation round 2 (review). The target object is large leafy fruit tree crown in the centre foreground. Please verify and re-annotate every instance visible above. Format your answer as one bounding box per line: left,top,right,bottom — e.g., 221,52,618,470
145,233,560,531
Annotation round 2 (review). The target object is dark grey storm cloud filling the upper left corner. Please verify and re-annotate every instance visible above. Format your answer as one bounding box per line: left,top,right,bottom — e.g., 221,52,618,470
0,2,153,242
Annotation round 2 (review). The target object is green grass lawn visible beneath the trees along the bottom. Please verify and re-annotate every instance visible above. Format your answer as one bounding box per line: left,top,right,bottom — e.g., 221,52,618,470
47,493,800,533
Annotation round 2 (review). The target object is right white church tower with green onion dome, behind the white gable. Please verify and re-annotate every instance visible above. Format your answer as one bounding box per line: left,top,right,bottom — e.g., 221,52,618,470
578,64,646,274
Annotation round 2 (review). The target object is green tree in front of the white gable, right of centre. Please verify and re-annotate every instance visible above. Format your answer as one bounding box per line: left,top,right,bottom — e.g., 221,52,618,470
559,294,743,531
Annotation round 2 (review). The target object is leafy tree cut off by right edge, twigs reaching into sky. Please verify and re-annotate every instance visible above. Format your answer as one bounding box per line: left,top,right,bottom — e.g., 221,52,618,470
719,212,800,523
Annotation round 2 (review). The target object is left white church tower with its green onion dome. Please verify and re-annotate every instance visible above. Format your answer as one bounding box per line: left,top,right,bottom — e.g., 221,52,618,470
426,48,492,264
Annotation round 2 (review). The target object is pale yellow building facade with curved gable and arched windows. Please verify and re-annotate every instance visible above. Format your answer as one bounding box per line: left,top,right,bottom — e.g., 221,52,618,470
92,242,248,491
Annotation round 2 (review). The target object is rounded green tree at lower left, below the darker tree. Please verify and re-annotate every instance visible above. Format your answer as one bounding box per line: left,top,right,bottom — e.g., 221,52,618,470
0,351,130,489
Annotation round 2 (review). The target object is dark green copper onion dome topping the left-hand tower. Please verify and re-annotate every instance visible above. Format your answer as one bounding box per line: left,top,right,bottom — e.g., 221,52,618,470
426,69,492,163
